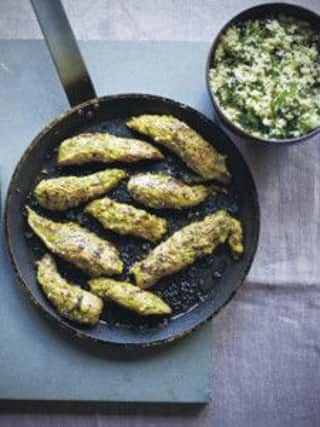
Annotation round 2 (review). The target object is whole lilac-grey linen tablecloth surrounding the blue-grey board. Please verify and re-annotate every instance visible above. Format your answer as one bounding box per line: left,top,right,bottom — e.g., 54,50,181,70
0,0,320,427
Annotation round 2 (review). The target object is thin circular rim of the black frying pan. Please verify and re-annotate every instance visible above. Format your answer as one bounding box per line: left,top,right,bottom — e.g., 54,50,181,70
4,93,260,348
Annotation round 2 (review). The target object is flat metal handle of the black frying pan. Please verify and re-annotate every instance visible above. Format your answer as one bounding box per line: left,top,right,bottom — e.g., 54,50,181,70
31,0,96,106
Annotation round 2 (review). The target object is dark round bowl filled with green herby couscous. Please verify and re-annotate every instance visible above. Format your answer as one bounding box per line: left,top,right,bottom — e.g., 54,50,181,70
207,3,320,145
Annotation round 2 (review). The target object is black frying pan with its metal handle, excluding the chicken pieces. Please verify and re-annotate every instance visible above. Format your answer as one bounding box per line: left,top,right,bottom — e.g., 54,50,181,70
5,0,259,346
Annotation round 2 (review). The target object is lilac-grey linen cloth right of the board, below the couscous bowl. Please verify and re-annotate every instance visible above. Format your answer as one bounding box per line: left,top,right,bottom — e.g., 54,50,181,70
208,136,320,427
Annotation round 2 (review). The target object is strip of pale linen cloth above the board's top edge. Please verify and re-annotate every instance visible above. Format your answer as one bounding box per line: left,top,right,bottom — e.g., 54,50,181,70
0,0,320,41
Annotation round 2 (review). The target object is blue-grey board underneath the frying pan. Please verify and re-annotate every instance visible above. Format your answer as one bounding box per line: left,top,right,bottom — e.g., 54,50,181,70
0,40,212,403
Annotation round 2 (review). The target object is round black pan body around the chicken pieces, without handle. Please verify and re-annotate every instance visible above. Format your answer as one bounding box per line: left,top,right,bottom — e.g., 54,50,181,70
6,95,259,344
